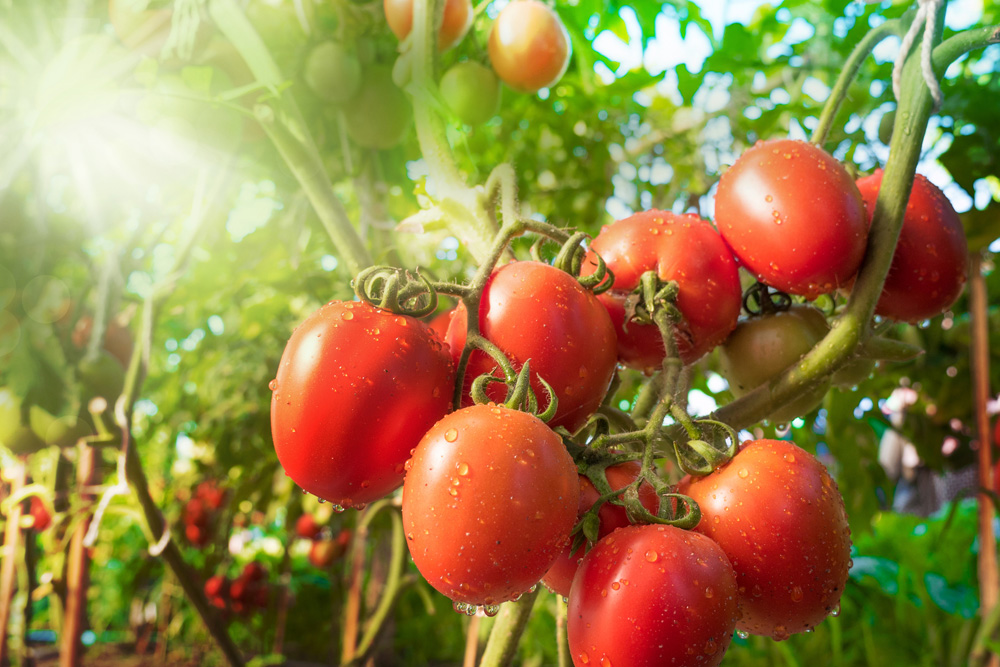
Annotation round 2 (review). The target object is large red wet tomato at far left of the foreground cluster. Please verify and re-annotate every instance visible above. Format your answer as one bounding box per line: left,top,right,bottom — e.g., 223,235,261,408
271,301,454,507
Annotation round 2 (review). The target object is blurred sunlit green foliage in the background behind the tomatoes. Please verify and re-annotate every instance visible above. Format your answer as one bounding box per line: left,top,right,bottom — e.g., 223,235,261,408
0,0,1000,665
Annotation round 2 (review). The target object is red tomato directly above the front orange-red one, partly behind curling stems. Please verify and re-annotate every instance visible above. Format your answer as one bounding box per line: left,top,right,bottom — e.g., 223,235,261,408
448,262,617,431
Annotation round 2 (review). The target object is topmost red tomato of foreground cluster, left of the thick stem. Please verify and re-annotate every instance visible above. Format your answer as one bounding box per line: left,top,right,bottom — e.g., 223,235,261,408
715,140,868,298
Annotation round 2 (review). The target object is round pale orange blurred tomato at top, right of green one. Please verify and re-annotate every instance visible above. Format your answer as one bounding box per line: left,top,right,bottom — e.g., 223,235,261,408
489,0,571,93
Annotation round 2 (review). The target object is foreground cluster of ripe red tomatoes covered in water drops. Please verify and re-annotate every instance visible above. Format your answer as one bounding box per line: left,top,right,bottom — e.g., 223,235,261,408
271,128,964,667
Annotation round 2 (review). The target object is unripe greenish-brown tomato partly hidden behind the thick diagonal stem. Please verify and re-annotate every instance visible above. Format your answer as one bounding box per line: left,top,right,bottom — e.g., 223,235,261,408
719,305,830,423
